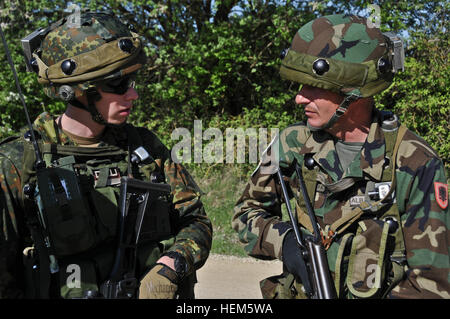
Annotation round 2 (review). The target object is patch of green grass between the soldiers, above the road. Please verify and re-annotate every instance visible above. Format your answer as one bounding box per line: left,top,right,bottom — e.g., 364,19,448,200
188,165,251,257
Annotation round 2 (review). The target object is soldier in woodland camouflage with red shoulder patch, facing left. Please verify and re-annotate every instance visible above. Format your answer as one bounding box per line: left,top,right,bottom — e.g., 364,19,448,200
232,15,450,298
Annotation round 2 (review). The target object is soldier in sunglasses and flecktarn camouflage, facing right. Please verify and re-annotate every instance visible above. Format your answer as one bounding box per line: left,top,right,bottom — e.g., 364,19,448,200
0,12,212,298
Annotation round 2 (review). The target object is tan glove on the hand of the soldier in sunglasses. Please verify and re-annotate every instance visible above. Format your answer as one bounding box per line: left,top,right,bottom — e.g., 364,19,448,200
139,264,178,299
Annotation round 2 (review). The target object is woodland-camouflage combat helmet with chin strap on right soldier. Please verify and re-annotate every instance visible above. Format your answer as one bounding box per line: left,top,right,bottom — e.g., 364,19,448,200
280,14,404,129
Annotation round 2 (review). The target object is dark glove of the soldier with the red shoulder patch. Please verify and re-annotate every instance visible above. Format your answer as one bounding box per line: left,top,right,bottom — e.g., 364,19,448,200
281,231,307,284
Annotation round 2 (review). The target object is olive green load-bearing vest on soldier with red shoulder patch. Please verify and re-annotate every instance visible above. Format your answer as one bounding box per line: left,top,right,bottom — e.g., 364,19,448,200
294,114,407,298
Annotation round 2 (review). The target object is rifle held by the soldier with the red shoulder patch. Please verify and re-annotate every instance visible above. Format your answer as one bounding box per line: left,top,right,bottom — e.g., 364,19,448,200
277,163,337,299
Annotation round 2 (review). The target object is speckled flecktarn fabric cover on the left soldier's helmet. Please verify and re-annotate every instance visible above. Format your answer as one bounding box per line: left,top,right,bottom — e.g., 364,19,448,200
33,12,146,97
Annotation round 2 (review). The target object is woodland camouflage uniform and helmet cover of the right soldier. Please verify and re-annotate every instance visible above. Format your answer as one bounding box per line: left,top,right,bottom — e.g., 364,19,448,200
232,15,450,298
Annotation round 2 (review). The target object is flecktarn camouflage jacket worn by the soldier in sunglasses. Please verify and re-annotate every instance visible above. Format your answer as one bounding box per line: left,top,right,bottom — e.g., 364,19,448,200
0,113,212,298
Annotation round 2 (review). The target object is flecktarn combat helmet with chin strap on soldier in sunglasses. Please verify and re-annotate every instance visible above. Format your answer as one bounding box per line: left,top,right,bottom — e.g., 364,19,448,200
22,12,146,124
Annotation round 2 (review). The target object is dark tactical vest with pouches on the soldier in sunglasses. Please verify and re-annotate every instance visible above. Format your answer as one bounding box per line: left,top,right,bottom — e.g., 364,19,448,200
24,125,177,298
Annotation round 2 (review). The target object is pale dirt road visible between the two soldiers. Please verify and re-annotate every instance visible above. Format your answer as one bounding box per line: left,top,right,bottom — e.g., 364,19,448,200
195,255,282,299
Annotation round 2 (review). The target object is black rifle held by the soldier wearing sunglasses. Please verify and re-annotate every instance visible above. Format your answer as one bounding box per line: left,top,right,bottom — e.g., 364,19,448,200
99,176,171,299
